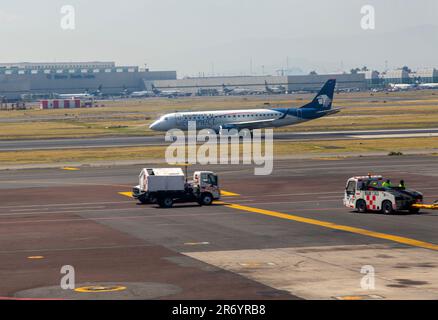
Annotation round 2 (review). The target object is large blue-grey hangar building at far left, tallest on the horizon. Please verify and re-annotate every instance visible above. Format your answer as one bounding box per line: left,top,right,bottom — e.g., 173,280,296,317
0,62,176,99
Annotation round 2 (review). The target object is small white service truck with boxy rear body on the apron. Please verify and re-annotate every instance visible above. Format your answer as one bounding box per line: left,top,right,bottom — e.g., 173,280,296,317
132,168,220,208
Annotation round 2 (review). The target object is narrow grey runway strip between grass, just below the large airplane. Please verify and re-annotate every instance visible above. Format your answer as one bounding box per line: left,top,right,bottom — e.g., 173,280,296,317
0,128,438,151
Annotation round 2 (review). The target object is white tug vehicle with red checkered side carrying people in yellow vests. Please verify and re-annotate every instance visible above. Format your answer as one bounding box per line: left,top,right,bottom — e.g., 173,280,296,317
344,175,423,214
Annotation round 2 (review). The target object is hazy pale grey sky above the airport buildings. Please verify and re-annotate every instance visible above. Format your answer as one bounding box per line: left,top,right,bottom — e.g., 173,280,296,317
0,0,438,77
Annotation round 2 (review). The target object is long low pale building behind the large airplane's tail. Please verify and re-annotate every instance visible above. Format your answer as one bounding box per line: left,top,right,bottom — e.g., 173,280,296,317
152,74,367,93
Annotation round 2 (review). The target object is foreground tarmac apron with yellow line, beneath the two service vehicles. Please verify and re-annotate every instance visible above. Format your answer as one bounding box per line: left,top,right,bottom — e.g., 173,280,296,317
0,156,438,299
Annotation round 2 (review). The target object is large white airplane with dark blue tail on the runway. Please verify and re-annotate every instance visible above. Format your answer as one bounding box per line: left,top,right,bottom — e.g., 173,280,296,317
150,79,339,134
